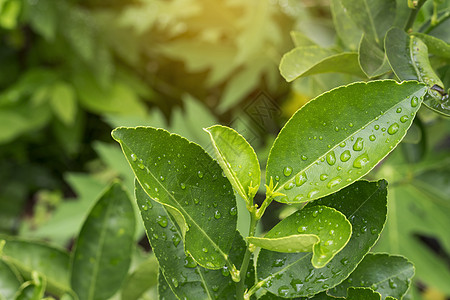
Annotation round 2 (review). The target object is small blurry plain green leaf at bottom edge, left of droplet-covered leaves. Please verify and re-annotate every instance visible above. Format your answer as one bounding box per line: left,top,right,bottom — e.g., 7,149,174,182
121,255,159,300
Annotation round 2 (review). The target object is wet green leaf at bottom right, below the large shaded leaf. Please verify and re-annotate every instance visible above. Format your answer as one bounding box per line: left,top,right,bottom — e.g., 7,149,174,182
328,253,414,299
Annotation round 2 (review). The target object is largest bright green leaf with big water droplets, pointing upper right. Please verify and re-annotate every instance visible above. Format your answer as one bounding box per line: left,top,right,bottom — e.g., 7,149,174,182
266,80,426,203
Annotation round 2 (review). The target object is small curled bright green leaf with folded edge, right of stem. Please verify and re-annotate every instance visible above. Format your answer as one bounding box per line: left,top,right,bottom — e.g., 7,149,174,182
247,206,352,268
